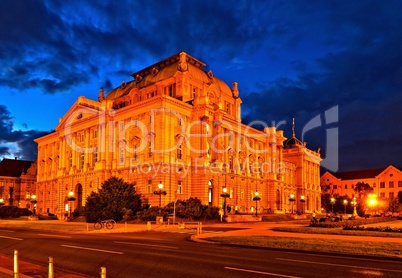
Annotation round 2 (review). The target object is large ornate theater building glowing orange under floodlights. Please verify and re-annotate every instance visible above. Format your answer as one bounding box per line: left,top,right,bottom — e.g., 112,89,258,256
35,52,321,216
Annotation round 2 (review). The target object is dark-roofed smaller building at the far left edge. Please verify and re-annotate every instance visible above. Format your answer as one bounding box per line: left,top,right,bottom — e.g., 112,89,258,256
0,158,36,208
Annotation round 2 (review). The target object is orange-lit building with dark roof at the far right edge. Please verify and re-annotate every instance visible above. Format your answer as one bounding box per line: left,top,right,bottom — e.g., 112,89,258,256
321,165,402,199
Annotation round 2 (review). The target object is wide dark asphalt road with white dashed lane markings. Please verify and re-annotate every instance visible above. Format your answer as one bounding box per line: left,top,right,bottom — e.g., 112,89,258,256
0,229,402,278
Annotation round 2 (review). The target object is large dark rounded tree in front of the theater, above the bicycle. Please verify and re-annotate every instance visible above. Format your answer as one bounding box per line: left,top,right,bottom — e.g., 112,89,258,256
85,177,141,222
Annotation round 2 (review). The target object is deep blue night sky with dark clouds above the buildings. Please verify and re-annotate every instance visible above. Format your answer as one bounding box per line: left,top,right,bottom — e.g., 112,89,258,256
0,0,402,171
